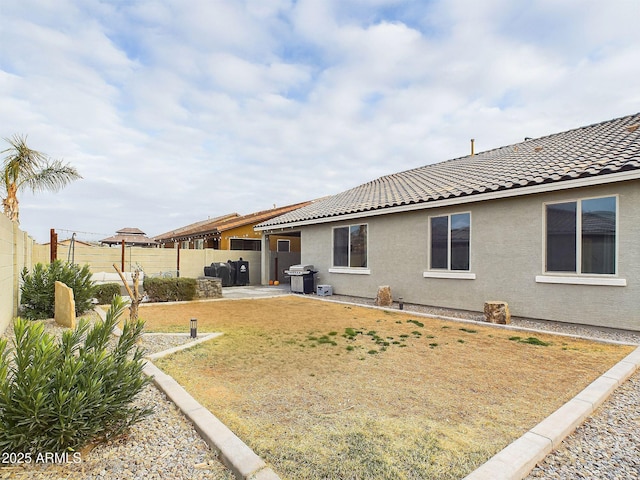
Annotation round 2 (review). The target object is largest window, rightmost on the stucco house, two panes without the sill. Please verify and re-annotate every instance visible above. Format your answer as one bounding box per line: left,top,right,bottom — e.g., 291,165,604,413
546,197,617,274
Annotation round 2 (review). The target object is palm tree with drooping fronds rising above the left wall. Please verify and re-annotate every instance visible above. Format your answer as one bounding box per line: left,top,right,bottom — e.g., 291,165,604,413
0,135,82,223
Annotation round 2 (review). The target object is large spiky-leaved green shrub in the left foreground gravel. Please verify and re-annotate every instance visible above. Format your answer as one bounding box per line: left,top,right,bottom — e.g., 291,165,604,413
0,297,152,455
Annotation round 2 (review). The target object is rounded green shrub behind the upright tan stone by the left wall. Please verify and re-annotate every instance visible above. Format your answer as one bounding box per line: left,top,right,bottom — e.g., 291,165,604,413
20,260,95,320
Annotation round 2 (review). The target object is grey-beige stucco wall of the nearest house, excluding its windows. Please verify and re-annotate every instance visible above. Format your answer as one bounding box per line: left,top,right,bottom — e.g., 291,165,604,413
301,181,640,330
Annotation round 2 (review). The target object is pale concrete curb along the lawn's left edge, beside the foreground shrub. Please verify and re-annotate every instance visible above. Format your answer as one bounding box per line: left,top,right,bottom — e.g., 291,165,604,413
144,362,280,480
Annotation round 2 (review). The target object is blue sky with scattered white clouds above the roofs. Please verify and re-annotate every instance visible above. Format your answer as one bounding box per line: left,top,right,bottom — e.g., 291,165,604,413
0,0,640,243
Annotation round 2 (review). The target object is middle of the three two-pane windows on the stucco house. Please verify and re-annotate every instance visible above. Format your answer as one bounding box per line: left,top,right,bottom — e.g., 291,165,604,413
430,213,471,270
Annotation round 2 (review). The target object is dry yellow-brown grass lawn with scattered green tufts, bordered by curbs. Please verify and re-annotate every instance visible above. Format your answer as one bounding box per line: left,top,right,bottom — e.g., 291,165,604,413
135,296,632,479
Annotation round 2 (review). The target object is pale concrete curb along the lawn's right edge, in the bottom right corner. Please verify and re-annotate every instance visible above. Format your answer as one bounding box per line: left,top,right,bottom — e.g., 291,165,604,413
464,347,640,480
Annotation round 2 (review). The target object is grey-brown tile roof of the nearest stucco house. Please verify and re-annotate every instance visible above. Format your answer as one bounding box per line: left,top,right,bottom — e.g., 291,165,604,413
258,113,640,228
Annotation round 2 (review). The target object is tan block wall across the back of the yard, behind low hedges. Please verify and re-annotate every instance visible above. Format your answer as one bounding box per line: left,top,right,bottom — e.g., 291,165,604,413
33,245,261,284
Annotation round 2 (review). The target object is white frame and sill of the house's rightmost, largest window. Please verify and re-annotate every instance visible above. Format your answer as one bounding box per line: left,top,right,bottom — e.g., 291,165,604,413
535,194,627,287
